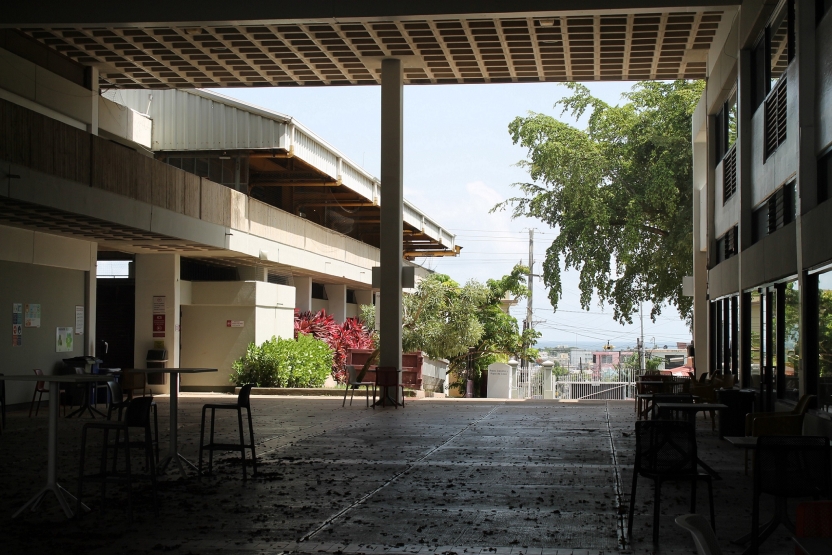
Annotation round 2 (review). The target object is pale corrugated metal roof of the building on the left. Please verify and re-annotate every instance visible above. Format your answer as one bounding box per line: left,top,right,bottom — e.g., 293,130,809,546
102,89,456,249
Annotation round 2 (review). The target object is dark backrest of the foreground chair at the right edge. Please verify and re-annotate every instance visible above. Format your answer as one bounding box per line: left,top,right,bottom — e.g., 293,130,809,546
754,436,832,497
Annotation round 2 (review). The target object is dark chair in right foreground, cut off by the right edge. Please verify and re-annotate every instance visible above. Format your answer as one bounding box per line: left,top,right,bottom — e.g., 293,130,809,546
742,436,832,555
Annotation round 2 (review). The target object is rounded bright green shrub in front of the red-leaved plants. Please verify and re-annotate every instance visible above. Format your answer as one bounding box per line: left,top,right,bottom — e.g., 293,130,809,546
231,334,332,387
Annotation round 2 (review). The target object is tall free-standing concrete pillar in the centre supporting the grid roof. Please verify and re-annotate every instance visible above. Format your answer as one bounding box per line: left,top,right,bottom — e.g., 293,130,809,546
377,58,404,382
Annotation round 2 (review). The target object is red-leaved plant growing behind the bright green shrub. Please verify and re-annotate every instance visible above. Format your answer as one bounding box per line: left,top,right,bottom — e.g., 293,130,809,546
295,309,373,383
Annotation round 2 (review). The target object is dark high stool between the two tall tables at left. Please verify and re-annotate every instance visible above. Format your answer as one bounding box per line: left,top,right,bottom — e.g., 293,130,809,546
75,397,158,522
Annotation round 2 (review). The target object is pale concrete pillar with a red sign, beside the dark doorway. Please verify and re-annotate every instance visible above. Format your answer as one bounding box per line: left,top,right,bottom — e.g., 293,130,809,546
133,254,181,393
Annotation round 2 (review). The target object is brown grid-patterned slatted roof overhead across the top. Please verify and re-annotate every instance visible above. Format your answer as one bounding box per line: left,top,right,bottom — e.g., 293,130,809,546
14,7,725,88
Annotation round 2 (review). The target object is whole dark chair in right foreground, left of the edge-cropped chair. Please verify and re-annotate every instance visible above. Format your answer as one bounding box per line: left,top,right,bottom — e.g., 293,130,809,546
627,420,716,545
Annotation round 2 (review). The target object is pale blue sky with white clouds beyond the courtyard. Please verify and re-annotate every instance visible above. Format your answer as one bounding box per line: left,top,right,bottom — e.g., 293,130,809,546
211,82,690,349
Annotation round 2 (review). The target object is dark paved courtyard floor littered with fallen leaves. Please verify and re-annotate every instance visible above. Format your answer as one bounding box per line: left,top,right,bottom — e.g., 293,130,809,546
0,394,794,555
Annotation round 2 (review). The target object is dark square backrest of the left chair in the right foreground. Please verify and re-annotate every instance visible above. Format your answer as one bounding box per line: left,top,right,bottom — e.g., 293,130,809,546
635,420,697,476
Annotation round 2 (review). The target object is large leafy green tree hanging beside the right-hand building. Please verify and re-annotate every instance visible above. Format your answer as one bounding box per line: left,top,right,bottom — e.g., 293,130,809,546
494,81,704,323
